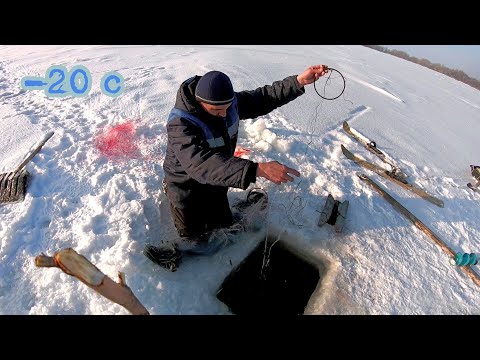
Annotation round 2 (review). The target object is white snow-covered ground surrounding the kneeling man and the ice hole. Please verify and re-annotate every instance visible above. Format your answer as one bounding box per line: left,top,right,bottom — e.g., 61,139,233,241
0,45,480,315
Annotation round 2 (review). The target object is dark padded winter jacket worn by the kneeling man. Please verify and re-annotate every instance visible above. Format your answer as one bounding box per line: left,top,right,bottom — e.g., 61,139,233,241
163,75,305,236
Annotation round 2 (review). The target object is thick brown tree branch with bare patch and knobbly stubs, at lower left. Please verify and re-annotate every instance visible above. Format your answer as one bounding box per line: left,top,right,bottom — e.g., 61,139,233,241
35,248,149,315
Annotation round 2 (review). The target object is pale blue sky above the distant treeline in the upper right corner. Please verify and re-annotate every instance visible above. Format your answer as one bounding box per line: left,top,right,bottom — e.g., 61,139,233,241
383,45,480,80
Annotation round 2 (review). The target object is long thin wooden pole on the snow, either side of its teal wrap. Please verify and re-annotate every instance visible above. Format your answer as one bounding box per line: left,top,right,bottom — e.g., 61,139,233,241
357,173,480,286
